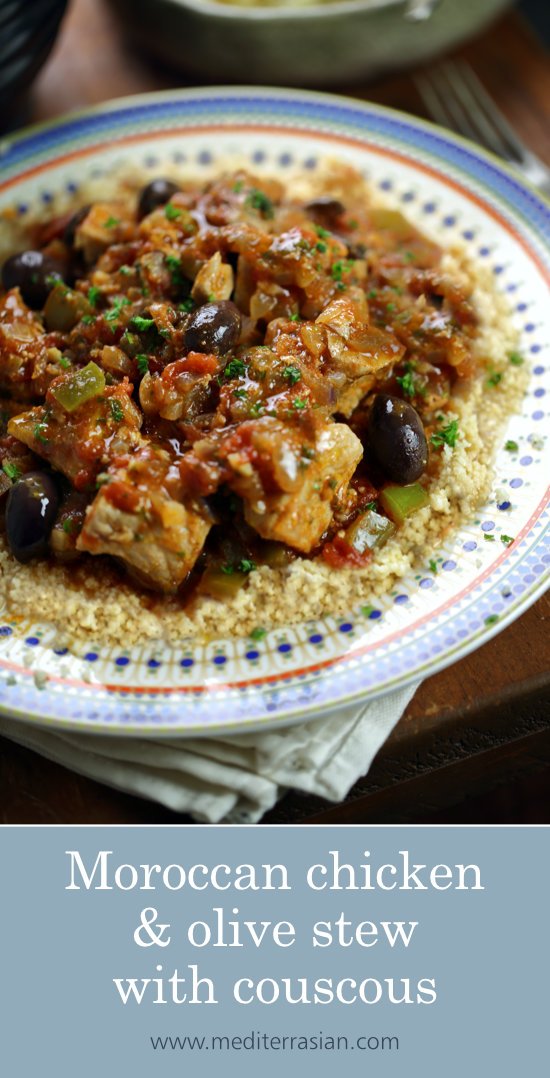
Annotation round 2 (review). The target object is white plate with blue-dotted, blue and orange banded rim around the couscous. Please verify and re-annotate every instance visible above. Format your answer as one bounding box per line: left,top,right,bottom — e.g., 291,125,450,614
0,88,550,736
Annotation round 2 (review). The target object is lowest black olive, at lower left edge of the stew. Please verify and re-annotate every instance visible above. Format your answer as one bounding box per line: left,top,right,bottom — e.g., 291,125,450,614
5,472,59,562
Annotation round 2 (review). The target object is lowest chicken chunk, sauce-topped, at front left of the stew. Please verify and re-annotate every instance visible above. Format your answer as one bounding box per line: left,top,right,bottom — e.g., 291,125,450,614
77,444,212,594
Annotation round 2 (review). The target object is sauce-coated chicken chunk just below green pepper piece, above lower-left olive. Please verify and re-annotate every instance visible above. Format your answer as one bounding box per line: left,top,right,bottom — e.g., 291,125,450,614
8,375,143,490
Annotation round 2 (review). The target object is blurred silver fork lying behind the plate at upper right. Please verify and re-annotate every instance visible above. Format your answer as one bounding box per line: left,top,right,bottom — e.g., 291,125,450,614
415,60,550,195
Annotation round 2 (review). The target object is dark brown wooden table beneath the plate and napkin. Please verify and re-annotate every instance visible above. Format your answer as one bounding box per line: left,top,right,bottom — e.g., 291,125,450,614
0,0,550,824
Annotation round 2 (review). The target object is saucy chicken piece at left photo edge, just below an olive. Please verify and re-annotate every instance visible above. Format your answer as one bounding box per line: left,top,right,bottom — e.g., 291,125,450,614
0,288,61,400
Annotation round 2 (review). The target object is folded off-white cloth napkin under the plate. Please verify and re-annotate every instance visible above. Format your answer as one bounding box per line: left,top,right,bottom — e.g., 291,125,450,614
0,682,420,824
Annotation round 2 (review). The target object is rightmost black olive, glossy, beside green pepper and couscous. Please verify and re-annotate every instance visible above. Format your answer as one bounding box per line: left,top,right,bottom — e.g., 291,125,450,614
368,393,428,484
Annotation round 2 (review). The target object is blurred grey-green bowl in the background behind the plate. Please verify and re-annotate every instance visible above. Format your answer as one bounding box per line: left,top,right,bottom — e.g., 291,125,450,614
110,0,510,86
